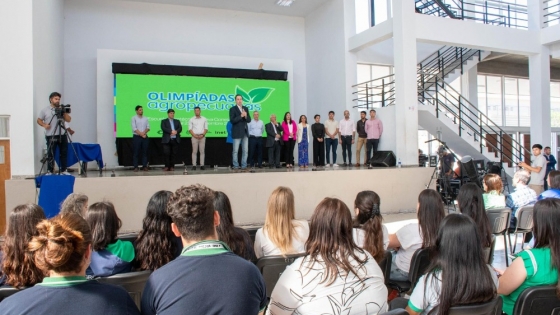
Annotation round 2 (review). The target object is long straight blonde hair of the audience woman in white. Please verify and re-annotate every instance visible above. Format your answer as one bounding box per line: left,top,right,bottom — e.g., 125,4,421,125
263,186,297,255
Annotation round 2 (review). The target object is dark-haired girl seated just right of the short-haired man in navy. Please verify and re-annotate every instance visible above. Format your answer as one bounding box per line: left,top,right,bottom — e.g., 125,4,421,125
214,191,256,261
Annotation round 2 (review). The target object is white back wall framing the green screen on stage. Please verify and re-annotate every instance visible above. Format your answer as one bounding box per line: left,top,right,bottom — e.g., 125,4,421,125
64,0,307,165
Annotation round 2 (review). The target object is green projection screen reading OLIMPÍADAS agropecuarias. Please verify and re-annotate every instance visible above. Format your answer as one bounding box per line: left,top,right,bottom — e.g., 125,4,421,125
114,73,290,138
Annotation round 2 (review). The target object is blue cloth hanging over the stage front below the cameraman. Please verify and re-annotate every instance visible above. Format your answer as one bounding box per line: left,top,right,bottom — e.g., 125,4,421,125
35,175,76,218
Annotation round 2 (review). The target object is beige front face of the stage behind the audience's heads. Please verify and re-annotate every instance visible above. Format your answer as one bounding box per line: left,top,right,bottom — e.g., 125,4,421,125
6,166,435,231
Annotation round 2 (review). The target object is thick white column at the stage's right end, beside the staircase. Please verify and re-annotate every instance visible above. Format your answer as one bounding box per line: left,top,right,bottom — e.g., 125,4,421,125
392,0,418,165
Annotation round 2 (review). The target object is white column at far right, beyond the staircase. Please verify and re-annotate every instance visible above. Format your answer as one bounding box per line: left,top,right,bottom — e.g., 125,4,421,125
527,0,551,149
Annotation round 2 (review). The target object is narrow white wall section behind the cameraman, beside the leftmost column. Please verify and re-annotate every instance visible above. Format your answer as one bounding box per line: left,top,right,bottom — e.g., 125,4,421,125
33,0,67,173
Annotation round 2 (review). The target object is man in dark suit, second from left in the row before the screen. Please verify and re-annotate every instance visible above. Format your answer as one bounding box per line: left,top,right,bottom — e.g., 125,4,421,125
161,109,183,171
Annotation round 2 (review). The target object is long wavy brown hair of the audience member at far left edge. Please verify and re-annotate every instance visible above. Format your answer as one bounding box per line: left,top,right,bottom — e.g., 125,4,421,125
0,203,45,288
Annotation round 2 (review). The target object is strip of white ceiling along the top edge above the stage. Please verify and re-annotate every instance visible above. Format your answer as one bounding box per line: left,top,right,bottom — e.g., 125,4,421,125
116,0,329,17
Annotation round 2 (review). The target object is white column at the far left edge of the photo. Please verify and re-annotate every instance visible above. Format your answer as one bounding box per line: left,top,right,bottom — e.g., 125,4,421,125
0,0,35,176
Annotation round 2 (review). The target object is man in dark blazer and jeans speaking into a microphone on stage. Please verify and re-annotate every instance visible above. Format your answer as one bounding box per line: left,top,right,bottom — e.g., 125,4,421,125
229,94,251,170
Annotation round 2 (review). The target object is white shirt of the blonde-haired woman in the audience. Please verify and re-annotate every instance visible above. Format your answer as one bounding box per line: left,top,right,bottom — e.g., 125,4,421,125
255,220,309,258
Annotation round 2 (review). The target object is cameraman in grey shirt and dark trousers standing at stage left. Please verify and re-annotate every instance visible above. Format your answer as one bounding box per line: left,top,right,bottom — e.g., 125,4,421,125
37,92,72,174
